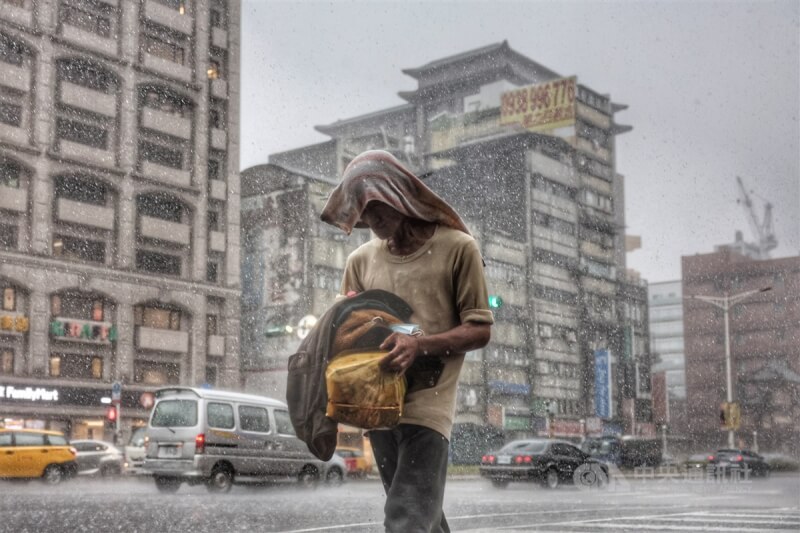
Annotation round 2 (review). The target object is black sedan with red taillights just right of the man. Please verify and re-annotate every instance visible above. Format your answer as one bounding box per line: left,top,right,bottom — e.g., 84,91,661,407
480,439,609,489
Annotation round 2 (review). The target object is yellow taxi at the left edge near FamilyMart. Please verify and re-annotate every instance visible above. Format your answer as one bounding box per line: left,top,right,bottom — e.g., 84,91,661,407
0,428,78,485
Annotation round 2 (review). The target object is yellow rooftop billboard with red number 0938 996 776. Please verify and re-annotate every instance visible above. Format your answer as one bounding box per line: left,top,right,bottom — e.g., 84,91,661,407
500,76,577,132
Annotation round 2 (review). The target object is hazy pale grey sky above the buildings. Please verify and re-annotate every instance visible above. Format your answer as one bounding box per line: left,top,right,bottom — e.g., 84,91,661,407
241,0,800,282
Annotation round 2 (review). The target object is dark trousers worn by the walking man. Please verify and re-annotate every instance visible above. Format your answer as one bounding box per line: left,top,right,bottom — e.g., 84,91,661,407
369,424,450,533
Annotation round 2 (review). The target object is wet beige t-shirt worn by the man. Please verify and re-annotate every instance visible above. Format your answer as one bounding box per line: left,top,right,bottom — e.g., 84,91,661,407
342,226,494,439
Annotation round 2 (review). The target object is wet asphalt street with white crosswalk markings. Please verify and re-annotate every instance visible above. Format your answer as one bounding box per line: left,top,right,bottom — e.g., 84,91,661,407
0,474,800,533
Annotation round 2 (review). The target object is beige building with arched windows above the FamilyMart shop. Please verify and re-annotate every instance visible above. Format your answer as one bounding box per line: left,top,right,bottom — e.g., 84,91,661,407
0,0,240,438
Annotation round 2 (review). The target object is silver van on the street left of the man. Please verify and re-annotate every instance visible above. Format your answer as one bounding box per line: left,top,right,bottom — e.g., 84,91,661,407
144,387,326,492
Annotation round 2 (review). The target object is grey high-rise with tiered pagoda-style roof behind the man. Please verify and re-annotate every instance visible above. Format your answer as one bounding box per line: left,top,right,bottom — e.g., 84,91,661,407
242,42,652,436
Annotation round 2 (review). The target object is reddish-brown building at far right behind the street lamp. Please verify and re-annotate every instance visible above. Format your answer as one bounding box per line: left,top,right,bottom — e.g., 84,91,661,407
682,249,800,454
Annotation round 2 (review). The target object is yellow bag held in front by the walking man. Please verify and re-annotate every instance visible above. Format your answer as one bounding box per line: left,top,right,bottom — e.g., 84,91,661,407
325,351,406,429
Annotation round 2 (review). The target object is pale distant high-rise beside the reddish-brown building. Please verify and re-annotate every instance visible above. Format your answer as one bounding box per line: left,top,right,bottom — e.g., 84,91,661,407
647,280,686,434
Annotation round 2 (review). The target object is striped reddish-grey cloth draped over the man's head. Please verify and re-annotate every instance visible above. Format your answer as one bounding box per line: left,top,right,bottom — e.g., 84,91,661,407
320,150,470,235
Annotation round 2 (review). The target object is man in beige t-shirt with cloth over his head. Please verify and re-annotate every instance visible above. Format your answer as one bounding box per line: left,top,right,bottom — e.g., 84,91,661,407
322,150,494,533
